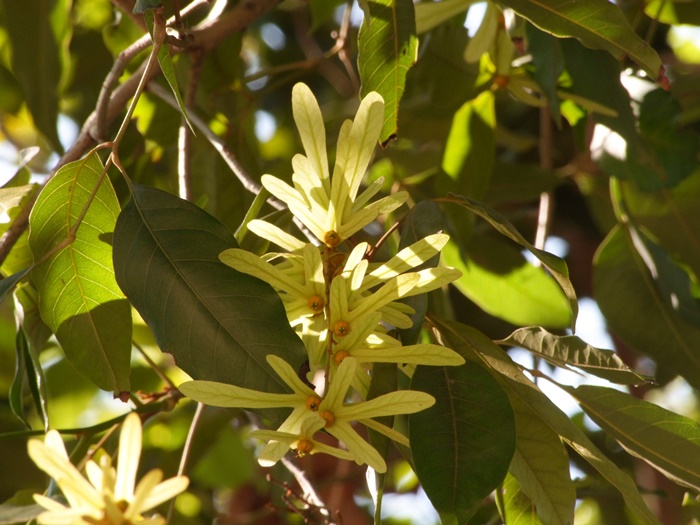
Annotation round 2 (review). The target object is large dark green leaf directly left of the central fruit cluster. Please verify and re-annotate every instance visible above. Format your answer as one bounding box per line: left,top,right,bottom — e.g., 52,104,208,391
114,185,306,404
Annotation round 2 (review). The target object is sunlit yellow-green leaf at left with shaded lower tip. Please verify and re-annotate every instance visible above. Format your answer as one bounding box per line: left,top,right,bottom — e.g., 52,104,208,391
29,154,131,392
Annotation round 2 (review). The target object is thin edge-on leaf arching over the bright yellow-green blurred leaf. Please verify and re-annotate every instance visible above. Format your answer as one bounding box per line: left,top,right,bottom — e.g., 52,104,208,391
450,195,578,329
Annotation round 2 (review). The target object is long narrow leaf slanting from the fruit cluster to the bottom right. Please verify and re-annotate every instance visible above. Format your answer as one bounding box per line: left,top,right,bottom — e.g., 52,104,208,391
433,319,660,525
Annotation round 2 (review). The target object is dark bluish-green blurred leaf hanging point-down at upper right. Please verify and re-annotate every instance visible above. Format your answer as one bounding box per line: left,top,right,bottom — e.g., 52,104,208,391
525,24,564,123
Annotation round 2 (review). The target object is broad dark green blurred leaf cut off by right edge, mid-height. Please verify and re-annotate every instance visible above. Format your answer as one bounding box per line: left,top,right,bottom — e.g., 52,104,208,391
593,227,700,386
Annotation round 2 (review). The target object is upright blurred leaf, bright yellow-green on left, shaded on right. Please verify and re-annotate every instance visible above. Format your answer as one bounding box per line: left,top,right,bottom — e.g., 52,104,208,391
440,91,496,199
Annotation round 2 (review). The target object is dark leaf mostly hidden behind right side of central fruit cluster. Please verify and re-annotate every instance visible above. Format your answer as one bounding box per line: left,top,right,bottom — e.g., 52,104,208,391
399,201,445,345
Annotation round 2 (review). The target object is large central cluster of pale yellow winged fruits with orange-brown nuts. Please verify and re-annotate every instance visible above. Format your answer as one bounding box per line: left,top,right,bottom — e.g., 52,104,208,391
180,84,464,472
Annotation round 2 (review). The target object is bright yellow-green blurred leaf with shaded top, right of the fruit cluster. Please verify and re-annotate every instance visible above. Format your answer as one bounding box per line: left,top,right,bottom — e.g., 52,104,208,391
442,236,571,328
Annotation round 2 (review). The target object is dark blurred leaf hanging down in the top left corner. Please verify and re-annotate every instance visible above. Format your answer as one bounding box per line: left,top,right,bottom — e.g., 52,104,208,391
3,0,63,152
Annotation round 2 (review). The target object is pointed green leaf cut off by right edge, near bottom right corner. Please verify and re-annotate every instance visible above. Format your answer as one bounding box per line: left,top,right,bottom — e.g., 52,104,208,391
566,385,700,490
